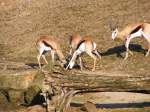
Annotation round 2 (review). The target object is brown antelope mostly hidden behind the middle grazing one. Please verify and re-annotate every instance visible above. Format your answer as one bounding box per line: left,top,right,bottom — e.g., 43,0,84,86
69,33,82,55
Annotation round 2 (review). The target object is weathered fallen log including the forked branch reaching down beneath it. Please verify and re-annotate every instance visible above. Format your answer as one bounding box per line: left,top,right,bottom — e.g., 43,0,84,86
43,68,150,112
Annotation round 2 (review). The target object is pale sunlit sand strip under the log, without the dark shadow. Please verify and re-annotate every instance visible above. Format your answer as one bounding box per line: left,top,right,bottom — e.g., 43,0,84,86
74,92,150,104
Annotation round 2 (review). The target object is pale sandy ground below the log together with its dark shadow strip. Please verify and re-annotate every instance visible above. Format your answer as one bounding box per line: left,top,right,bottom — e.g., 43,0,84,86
72,92,150,112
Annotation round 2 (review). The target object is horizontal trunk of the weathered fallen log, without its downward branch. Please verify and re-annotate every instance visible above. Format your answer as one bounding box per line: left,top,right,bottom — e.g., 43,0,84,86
44,69,150,93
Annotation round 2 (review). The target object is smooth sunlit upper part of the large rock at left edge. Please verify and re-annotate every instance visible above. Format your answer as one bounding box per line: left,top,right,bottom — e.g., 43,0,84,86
0,70,37,90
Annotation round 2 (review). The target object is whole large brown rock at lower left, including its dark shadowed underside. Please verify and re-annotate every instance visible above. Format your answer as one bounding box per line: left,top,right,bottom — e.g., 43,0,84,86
0,69,43,105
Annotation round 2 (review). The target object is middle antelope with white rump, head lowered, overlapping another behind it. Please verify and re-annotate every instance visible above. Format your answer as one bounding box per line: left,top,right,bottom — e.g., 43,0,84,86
66,37,101,71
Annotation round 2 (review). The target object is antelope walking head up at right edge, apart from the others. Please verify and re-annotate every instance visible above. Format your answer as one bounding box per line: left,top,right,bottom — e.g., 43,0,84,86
112,23,150,60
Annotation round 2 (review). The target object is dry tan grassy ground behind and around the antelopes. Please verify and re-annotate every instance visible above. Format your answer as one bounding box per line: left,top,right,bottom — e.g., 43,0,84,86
0,0,150,111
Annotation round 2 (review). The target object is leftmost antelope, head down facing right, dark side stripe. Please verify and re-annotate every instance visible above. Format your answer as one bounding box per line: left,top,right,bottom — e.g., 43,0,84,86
36,36,66,69
